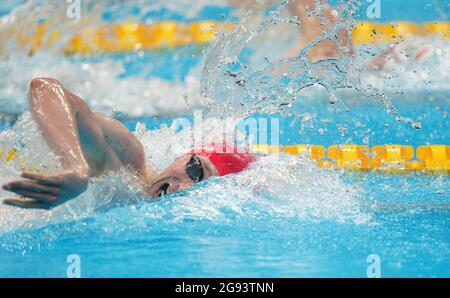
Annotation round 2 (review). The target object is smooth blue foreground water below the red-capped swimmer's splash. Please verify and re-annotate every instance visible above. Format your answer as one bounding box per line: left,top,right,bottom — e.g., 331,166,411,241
0,174,450,277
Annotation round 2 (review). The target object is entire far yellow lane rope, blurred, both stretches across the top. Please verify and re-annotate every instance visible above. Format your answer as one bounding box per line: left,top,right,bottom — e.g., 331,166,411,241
7,21,450,55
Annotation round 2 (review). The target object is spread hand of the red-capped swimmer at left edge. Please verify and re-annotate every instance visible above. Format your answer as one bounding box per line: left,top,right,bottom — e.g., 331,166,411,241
2,171,89,210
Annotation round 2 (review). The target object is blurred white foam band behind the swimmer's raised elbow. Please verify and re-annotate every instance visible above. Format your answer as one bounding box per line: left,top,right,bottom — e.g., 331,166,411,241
0,53,199,117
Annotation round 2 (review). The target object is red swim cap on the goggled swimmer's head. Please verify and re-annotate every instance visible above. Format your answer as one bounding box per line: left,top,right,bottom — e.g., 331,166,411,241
190,144,256,176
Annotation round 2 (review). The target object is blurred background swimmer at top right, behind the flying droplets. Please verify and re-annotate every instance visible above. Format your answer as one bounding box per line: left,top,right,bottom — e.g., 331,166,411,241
234,0,437,71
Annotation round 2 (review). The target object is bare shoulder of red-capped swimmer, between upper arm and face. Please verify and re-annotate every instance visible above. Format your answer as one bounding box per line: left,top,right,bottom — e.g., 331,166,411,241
94,112,145,170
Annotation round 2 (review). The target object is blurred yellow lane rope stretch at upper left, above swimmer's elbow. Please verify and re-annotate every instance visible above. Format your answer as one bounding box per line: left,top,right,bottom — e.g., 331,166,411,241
11,21,233,54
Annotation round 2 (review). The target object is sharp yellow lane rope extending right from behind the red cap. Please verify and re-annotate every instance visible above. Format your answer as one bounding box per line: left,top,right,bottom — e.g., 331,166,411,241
253,144,450,174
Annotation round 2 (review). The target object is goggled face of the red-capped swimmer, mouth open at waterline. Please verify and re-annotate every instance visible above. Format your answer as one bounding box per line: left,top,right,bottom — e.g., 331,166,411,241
150,154,219,198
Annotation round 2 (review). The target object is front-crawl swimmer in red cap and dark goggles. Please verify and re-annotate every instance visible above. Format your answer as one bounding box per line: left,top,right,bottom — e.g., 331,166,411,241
3,78,255,209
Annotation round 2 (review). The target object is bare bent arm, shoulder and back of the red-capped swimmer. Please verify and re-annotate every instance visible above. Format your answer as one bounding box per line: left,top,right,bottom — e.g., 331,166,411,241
3,78,154,209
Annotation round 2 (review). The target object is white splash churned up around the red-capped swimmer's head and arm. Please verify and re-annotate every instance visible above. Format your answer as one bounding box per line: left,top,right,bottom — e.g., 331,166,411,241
0,116,370,232
